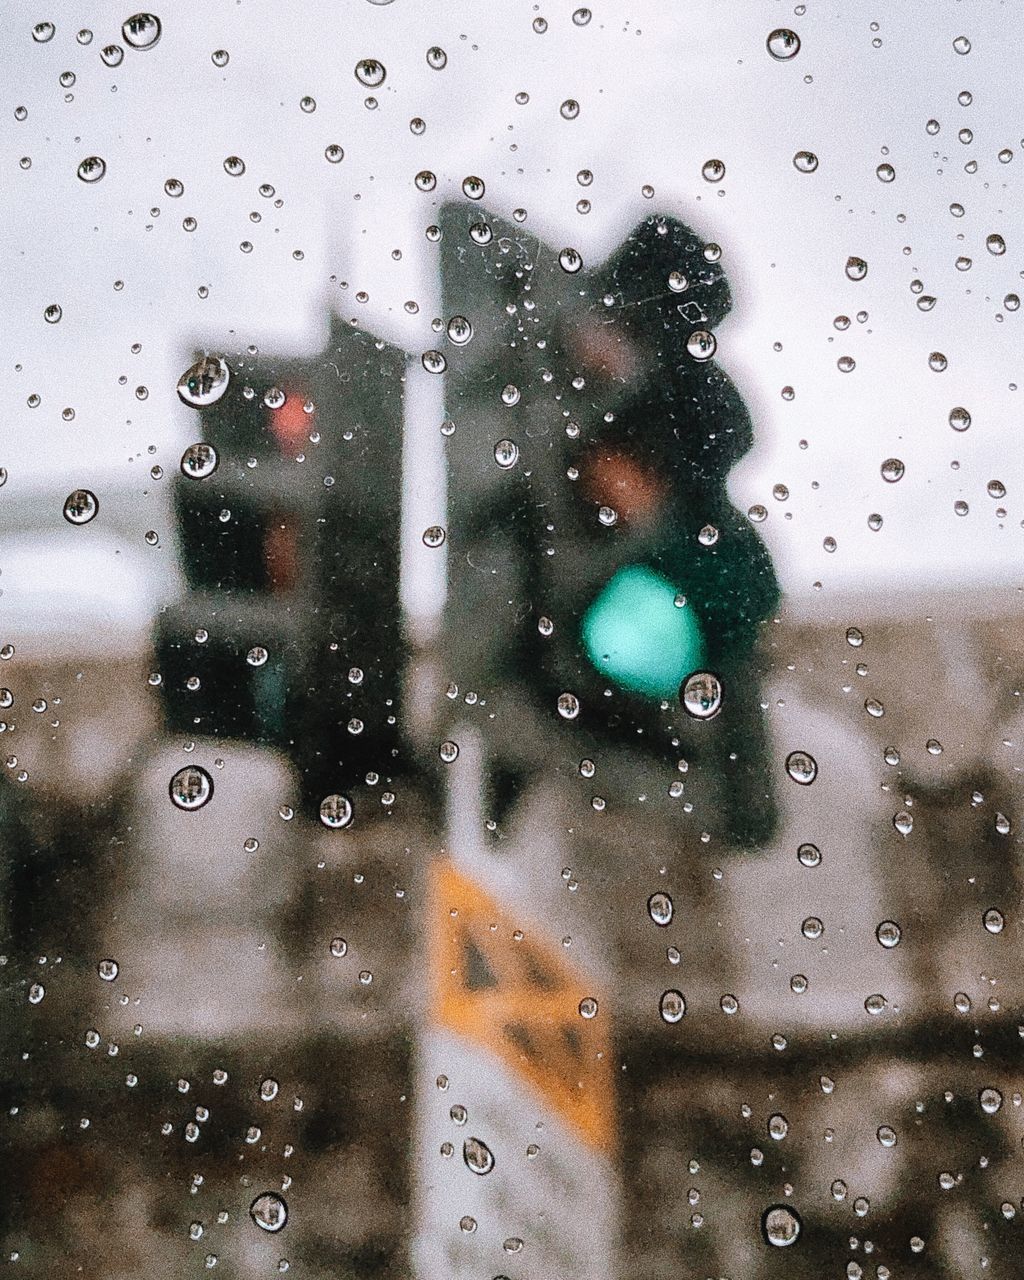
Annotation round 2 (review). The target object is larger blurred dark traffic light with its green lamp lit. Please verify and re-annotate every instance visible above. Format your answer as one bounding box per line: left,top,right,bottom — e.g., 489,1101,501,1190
442,205,778,844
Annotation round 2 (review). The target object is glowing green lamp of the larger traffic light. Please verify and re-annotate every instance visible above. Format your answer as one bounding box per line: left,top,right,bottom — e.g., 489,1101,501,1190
581,564,704,698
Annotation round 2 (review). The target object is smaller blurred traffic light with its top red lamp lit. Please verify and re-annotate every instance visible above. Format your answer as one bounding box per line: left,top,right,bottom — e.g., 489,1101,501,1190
156,320,404,813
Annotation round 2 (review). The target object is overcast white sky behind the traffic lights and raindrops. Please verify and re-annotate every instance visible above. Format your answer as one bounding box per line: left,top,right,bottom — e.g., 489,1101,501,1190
0,0,1024,640
